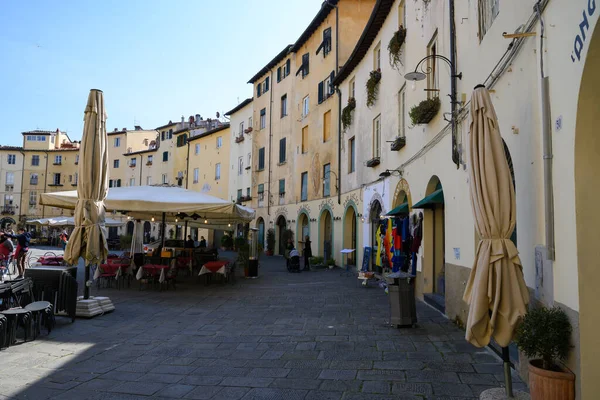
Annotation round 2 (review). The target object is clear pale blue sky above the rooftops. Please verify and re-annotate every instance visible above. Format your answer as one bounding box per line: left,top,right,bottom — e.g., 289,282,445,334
0,0,322,145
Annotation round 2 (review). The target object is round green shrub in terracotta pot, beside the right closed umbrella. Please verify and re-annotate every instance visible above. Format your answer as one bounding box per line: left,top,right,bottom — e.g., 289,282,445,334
515,307,575,400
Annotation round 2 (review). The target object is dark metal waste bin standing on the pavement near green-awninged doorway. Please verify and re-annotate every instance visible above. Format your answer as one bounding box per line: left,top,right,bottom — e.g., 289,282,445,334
386,272,417,327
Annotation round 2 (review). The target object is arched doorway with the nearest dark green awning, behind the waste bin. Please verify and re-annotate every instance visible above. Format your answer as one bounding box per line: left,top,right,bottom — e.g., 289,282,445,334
413,176,446,311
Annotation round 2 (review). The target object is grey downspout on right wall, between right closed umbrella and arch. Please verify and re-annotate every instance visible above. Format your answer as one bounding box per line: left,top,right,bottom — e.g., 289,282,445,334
534,1,555,261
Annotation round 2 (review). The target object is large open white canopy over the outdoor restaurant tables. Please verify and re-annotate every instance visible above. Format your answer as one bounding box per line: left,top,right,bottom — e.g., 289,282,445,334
40,186,255,227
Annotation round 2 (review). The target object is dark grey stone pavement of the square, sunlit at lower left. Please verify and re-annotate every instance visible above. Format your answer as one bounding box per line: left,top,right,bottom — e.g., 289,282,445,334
0,253,524,400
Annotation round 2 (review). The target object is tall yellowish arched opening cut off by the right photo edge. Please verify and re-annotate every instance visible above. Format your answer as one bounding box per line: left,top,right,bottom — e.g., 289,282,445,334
571,21,600,399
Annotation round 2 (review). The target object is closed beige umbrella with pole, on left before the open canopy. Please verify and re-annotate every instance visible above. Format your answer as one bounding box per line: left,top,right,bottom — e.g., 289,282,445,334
65,89,108,299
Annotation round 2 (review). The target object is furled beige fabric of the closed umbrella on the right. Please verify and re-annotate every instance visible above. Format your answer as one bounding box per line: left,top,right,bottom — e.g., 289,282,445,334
464,86,529,347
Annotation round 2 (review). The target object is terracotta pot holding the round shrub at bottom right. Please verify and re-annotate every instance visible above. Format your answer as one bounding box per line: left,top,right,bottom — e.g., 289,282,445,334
529,360,575,400
